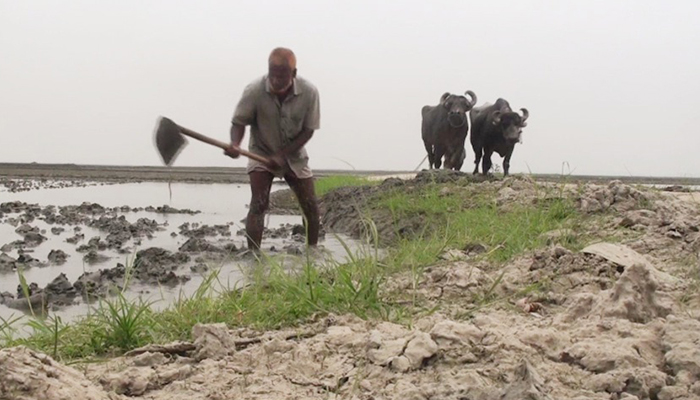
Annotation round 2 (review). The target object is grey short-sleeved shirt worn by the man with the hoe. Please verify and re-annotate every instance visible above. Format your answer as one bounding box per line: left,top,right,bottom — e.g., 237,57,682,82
231,75,321,179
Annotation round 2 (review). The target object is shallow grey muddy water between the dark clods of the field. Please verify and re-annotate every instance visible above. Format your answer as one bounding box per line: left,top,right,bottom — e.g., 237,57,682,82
0,182,366,321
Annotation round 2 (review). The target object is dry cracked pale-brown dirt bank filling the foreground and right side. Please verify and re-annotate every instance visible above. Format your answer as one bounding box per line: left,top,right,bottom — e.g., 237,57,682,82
0,173,700,400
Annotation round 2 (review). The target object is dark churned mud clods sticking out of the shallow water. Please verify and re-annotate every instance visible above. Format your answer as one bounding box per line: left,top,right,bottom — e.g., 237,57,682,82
0,202,305,311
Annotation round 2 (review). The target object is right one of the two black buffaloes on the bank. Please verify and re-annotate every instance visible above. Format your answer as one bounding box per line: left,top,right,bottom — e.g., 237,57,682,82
469,98,530,176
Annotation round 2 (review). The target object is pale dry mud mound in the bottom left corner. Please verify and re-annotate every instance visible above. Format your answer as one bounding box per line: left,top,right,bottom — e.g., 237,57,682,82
0,346,116,400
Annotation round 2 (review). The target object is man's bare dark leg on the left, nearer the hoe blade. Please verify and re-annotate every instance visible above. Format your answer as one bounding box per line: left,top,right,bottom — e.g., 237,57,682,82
245,171,274,250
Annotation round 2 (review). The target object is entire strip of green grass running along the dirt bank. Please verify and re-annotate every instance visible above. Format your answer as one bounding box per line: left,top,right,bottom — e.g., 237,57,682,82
0,176,580,361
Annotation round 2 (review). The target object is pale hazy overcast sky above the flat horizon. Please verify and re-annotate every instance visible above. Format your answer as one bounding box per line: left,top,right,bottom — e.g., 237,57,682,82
0,0,700,177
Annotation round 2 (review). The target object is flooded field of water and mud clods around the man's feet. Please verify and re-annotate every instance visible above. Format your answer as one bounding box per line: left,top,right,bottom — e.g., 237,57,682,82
0,181,359,321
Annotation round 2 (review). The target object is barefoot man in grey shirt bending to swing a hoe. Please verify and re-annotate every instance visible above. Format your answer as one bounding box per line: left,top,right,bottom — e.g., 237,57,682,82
224,48,321,251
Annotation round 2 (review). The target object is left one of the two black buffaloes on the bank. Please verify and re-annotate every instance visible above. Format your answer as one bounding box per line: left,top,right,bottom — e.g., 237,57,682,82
421,90,476,171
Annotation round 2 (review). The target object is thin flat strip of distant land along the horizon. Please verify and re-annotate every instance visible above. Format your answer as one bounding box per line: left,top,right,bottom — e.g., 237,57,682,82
0,163,700,186
